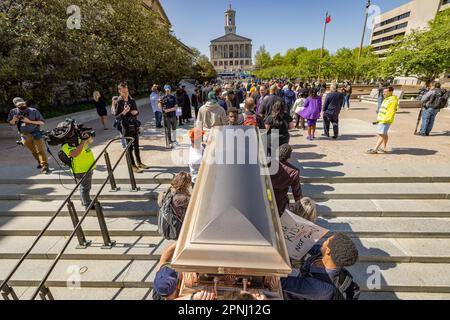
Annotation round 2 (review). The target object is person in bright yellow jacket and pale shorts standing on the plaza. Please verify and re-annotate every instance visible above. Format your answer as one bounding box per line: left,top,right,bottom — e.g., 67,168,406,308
367,87,398,154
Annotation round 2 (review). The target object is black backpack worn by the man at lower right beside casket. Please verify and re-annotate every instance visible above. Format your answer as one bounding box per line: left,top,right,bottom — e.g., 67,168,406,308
301,253,361,301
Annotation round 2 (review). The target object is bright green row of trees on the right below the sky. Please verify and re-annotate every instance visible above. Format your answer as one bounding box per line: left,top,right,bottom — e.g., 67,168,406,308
255,10,450,82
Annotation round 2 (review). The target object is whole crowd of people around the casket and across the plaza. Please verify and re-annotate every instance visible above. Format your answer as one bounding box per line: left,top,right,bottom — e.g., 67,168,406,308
8,80,448,300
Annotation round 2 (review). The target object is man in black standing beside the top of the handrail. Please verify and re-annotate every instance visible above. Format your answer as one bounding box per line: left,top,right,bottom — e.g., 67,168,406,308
115,83,150,173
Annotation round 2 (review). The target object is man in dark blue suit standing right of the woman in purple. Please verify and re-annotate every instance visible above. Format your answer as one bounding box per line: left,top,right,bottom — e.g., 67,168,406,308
323,84,344,139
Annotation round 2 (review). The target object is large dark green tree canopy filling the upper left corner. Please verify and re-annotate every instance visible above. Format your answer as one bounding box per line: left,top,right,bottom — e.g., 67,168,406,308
0,0,193,110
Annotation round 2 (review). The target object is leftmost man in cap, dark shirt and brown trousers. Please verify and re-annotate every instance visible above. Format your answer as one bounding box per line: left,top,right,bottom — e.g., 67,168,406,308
8,97,50,174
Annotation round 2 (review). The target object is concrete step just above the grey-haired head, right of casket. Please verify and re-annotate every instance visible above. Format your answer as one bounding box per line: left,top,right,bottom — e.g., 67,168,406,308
303,183,450,200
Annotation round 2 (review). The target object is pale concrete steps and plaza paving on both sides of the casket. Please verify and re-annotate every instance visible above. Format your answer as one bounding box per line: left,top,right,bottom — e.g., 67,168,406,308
0,99,450,299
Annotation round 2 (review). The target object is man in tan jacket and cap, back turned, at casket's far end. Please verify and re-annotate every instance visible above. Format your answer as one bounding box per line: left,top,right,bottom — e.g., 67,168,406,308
197,87,228,130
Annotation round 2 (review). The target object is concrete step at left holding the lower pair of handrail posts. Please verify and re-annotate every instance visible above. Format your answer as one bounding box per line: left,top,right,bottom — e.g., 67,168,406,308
0,236,171,260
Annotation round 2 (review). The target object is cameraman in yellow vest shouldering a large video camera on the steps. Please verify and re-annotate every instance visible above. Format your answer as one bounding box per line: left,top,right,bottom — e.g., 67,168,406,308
61,137,96,209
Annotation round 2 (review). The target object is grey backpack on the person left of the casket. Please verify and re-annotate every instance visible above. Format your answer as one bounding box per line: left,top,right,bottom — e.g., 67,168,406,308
158,189,183,240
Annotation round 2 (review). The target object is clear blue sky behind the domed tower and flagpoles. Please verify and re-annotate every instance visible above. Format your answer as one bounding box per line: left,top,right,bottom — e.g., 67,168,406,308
161,0,409,56
